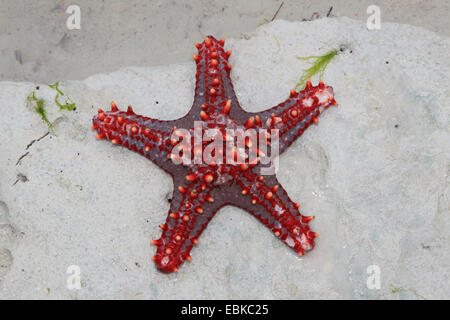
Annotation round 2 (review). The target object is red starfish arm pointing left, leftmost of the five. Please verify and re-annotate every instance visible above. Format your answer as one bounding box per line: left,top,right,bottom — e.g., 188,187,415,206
92,103,178,171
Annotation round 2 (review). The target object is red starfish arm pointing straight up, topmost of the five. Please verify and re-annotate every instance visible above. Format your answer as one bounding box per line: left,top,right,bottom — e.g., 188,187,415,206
188,36,245,121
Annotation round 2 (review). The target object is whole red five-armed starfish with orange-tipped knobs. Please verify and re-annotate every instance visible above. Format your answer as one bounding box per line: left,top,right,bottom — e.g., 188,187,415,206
93,36,337,273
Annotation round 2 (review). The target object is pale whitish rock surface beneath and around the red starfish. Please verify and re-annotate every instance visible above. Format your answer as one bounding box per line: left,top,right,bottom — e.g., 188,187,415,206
0,18,450,299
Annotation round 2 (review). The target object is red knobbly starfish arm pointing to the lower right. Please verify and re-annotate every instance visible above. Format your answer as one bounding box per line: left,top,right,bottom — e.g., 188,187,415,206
233,169,317,255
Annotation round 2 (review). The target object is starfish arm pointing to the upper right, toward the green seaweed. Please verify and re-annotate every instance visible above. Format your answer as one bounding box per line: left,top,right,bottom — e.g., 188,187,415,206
250,80,337,154
